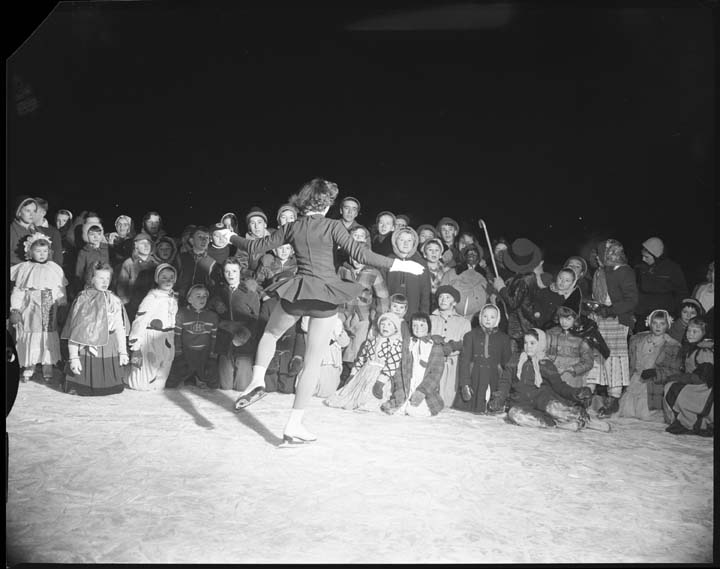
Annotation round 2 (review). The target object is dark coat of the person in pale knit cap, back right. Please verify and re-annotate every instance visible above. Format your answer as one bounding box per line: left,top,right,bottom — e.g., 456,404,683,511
635,256,689,316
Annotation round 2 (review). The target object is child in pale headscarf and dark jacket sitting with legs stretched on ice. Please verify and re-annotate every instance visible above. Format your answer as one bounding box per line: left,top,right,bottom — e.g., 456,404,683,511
488,328,610,431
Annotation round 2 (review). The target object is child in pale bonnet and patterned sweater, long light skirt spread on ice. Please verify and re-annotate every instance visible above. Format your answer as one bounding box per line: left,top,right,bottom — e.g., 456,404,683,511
324,312,403,411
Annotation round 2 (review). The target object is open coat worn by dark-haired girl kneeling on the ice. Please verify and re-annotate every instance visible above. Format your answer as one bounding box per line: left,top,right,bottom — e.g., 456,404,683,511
382,336,445,415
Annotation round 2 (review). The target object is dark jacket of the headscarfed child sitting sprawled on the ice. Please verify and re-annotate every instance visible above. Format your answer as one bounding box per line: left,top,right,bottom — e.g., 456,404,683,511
493,354,576,406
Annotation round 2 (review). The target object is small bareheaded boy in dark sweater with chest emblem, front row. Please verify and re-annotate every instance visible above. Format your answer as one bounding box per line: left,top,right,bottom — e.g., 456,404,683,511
167,286,219,389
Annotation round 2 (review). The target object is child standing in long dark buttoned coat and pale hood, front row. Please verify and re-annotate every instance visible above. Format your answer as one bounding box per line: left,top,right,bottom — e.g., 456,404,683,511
453,304,512,414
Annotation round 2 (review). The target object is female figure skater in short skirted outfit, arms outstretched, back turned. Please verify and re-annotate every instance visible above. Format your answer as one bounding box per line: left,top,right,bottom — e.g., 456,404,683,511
226,178,424,446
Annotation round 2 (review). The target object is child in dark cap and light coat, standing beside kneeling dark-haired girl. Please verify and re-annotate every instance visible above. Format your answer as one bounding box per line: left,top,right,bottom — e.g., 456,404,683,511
430,285,470,407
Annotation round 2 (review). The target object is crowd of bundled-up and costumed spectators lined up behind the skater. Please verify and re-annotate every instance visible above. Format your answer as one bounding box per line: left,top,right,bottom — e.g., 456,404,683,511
7,191,715,435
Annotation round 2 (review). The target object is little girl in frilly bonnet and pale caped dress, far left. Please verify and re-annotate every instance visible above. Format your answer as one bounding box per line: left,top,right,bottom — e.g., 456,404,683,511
10,233,67,381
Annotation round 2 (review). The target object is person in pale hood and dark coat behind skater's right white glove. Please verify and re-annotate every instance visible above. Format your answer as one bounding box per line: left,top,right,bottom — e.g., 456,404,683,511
387,227,431,322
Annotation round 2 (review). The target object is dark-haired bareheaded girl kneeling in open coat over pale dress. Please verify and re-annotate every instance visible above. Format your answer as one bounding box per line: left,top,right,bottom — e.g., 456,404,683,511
381,312,445,417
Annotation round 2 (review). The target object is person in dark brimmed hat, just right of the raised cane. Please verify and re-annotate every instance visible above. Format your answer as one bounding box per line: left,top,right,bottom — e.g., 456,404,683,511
493,237,543,353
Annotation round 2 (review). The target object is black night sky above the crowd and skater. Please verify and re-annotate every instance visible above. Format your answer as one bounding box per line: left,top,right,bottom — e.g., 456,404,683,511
7,2,716,281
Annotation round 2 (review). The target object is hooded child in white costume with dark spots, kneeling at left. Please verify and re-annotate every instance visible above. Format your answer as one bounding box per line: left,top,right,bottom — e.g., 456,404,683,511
126,263,178,391
